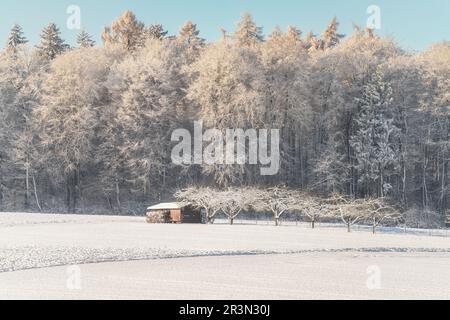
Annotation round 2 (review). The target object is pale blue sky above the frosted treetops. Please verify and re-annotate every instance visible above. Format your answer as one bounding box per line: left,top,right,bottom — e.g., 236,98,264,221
0,0,450,50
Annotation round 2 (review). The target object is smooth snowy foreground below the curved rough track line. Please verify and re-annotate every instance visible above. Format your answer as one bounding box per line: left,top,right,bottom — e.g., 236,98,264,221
0,253,450,300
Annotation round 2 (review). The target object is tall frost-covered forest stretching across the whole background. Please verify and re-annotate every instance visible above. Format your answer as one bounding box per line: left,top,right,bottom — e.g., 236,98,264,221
0,11,450,224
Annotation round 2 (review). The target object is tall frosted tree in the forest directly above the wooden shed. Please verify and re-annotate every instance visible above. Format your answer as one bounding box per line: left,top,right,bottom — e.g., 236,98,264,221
109,40,184,197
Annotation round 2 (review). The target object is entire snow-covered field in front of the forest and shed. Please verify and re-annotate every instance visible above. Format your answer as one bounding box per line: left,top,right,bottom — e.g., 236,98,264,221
0,213,450,300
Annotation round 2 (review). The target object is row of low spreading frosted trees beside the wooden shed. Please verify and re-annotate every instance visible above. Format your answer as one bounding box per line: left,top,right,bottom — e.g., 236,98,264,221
174,187,400,234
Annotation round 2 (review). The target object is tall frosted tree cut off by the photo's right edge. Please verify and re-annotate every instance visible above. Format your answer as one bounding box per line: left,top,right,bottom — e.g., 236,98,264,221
414,42,450,214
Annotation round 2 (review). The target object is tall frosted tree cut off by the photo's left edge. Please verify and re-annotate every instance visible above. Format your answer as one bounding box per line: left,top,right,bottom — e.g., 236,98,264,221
0,46,45,210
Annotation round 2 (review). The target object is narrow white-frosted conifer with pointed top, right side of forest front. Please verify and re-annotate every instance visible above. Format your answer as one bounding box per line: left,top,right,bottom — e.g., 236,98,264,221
351,70,400,197
